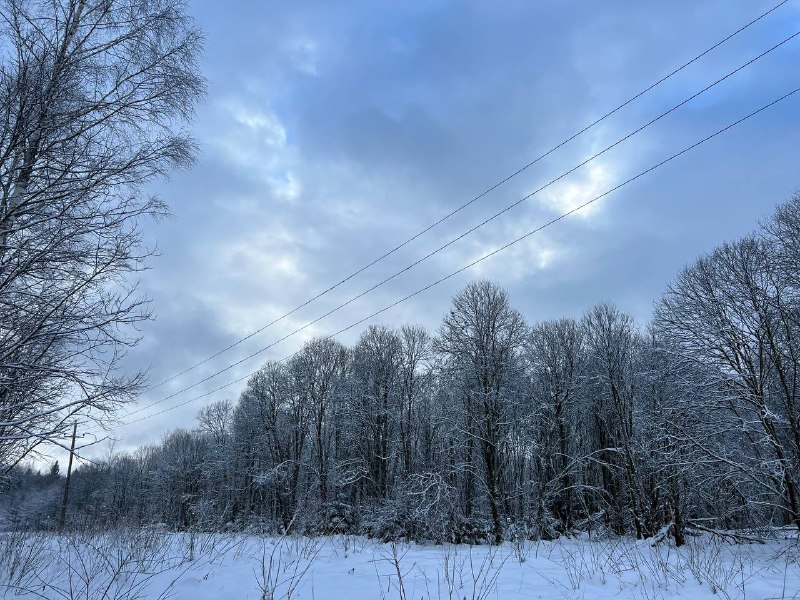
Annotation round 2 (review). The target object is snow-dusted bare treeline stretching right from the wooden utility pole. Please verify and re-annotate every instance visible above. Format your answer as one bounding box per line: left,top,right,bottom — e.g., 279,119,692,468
6,195,800,544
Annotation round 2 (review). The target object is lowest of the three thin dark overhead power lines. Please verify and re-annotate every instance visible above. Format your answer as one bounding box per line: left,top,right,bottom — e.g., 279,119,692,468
112,87,800,432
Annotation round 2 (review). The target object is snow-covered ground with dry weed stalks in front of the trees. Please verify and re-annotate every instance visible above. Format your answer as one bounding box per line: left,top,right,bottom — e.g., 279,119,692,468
0,530,800,600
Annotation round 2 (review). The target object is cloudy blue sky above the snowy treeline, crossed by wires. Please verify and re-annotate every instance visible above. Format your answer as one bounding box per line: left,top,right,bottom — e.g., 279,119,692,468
72,0,800,456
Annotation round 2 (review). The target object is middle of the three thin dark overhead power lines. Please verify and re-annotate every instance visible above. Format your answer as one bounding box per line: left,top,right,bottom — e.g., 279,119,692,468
112,25,800,424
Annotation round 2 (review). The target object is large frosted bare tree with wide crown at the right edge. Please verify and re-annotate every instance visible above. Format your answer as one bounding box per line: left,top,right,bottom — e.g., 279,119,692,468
656,236,800,526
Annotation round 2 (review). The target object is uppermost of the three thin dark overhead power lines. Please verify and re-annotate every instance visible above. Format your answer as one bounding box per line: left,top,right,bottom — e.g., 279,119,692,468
146,0,789,392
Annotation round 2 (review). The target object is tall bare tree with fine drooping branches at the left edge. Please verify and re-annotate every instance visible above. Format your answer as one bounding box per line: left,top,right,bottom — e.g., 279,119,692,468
0,0,204,464
